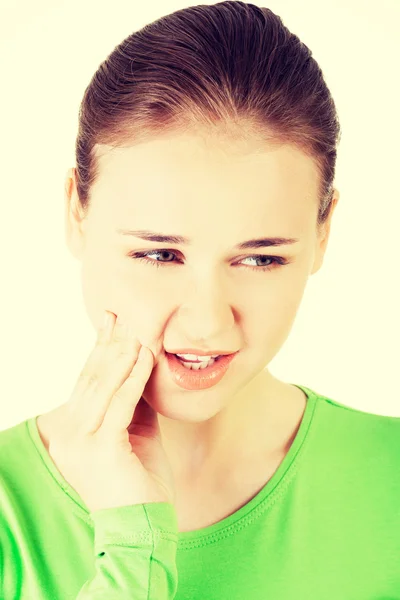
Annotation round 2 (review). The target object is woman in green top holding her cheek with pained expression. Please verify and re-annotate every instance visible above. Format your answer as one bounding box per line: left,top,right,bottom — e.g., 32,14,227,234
0,2,400,600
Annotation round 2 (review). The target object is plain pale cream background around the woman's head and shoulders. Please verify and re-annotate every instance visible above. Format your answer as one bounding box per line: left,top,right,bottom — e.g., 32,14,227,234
0,0,400,429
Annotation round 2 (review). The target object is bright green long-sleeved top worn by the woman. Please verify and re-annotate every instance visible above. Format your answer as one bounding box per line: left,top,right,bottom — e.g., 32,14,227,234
0,384,400,600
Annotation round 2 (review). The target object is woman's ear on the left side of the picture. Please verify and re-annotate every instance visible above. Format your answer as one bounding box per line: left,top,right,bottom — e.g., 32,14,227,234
64,168,85,260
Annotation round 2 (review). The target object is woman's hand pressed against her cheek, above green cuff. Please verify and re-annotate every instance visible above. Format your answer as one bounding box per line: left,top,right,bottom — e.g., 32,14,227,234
49,313,175,512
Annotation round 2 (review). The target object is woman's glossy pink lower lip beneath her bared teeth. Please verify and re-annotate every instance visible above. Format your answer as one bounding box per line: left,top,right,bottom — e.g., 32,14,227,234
165,352,239,390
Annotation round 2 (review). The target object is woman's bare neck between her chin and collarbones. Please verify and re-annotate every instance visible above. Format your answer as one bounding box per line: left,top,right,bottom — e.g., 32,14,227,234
158,370,306,485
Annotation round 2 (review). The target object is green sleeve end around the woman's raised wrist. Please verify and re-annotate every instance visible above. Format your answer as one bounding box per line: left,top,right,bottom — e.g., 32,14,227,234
76,502,178,600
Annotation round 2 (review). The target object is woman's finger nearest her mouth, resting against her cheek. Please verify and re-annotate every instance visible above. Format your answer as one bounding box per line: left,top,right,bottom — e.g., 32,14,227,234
99,346,154,437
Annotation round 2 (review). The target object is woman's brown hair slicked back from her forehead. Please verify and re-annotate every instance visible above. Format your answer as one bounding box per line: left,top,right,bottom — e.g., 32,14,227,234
75,0,341,228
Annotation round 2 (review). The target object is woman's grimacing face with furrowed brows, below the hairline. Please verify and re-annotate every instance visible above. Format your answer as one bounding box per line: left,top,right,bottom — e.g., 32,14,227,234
66,134,338,421
